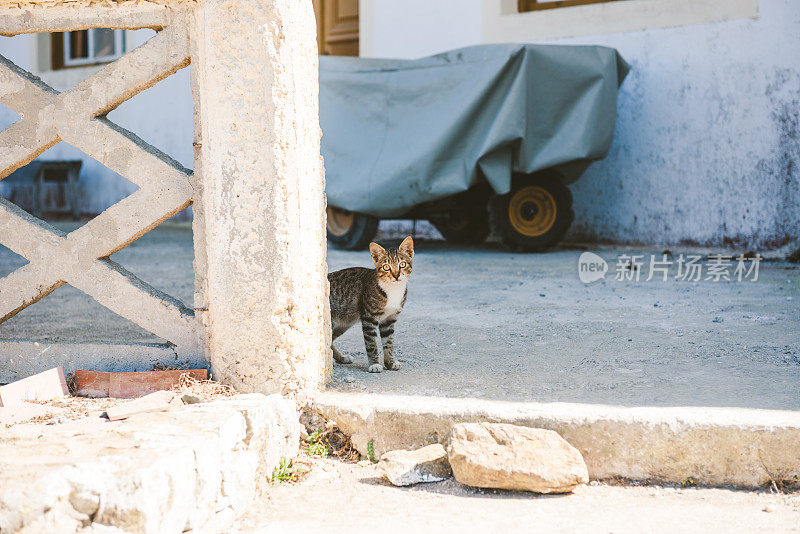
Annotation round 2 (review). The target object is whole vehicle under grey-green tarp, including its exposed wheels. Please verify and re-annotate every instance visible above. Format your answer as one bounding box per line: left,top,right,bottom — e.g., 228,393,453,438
320,45,628,251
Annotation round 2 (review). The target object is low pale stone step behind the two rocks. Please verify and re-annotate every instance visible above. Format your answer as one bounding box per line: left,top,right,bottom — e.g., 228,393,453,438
312,391,800,488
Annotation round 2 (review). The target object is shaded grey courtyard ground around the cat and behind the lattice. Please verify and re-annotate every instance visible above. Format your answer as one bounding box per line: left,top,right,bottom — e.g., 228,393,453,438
0,222,800,410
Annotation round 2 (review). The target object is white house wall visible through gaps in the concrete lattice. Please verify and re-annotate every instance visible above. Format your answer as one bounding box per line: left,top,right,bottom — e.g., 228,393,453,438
0,30,193,219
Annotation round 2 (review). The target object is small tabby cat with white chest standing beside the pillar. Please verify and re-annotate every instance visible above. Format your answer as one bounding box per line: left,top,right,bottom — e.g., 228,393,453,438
328,236,414,373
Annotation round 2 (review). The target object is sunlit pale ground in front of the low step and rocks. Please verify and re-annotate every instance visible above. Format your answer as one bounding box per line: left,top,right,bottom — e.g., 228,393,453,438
235,458,800,534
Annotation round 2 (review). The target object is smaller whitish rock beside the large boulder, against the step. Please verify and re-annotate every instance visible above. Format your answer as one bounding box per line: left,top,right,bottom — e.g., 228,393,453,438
378,443,453,486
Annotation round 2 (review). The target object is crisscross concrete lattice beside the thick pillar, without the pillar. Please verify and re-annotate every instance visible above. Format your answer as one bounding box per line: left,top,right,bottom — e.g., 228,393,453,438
0,8,203,370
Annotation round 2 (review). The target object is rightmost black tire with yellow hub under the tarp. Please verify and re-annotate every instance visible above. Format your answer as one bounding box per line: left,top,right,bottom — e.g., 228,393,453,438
489,172,575,252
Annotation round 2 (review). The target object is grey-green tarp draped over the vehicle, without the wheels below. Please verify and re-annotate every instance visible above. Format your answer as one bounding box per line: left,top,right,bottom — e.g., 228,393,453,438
320,44,628,217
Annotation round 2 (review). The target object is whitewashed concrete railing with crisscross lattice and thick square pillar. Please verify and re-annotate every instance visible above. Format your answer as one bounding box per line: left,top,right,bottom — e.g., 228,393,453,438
0,0,329,393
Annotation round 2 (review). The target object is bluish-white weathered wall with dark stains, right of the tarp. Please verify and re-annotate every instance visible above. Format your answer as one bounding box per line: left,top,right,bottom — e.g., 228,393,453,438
561,0,800,248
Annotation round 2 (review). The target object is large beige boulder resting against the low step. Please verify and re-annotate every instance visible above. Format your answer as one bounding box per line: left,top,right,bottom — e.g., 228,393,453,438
447,423,589,493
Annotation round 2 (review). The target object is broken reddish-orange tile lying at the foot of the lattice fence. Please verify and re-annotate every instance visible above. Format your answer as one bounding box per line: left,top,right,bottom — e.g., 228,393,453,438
75,369,208,399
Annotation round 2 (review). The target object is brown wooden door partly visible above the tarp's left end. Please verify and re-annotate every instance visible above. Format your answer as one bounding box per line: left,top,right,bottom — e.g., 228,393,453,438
314,0,358,56
